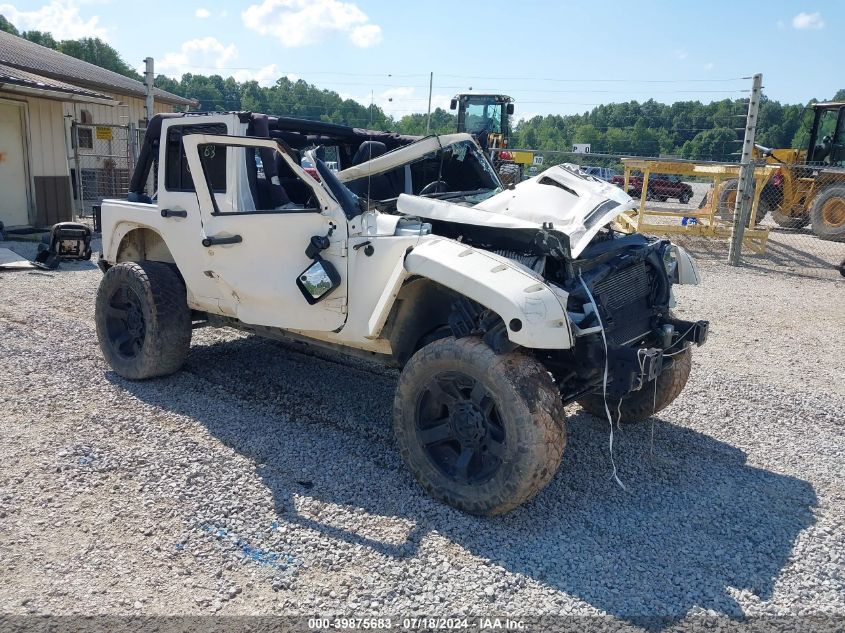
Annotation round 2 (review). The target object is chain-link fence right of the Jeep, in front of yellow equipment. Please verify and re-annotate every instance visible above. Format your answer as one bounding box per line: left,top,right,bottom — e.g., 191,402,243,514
492,150,845,278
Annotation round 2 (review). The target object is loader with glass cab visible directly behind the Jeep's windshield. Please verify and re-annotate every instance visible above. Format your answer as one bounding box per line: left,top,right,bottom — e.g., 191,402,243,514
449,93,534,184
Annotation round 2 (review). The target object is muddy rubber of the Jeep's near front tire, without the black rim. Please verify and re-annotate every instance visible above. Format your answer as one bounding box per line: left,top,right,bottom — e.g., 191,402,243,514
393,337,566,516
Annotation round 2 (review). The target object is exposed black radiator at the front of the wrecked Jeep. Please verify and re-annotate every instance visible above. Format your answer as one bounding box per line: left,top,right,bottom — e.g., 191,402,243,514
593,262,651,345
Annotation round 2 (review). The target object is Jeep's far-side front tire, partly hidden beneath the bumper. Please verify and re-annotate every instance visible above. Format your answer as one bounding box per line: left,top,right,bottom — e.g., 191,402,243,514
578,346,692,424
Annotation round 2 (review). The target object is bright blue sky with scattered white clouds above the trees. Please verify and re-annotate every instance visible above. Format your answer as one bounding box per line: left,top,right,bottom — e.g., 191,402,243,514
0,0,845,117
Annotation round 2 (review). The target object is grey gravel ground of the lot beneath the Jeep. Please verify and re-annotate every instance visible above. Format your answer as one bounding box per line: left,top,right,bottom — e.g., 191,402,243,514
0,243,845,621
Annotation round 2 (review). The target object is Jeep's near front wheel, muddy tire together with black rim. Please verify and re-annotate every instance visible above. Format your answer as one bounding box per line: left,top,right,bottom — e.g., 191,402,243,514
393,337,566,516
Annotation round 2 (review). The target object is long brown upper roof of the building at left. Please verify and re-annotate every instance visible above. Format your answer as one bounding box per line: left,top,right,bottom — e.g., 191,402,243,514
0,31,197,105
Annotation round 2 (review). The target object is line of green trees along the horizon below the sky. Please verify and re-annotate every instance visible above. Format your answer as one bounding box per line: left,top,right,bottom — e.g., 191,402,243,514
0,15,845,164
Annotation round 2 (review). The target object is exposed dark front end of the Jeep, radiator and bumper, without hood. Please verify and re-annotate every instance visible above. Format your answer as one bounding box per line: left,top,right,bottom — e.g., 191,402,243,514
541,230,708,402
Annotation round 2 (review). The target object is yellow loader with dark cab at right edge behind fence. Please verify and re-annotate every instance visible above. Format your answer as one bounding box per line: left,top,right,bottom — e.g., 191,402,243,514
717,102,845,241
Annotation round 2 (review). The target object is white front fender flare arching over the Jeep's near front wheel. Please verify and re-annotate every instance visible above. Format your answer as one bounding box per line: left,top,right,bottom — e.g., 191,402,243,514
405,237,572,349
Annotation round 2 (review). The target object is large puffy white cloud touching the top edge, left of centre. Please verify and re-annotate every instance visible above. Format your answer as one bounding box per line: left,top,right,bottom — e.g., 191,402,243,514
241,0,382,48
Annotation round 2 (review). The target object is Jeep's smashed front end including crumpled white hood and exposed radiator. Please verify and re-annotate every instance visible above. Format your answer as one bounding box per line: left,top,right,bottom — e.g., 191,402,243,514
397,159,708,402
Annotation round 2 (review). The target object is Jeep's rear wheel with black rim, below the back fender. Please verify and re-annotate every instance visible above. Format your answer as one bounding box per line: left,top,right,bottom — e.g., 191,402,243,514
94,261,191,380
